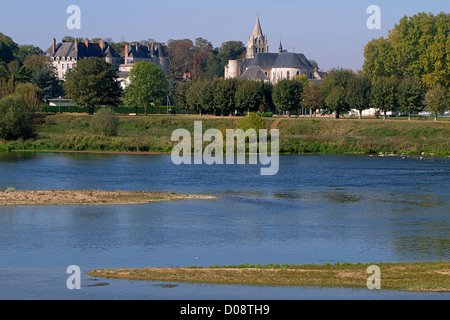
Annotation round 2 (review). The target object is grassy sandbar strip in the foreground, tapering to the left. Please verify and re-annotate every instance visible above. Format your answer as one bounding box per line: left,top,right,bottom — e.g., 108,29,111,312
88,262,450,292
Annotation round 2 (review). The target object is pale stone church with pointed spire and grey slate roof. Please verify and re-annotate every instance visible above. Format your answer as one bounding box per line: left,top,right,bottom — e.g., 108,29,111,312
225,17,322,84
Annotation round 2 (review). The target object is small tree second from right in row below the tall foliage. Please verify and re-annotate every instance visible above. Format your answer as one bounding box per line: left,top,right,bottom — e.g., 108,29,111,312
398,78,424,120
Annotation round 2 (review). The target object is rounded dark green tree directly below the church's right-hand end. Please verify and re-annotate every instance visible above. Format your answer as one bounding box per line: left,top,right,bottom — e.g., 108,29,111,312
273,79,303,116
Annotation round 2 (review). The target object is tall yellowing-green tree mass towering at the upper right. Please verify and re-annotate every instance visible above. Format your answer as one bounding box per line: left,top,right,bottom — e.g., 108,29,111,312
363,12,450,88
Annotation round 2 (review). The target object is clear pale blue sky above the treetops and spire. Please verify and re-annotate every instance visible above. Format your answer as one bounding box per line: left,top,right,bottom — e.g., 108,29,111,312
0,0,450,70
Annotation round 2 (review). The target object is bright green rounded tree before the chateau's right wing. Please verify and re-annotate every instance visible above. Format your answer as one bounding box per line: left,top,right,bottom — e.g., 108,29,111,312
124,61,168,114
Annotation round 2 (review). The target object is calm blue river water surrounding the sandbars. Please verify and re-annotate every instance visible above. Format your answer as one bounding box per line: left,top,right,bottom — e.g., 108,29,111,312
0,153,450,299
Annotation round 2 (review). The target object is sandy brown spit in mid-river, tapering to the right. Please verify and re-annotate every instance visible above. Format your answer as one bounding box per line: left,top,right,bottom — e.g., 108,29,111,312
0,188,217,206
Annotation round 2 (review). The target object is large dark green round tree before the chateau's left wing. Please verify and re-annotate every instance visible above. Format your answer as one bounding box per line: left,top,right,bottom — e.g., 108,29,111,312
64,57,122,114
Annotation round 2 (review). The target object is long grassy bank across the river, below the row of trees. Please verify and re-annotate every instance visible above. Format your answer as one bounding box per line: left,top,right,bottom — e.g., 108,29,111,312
0,114,450,156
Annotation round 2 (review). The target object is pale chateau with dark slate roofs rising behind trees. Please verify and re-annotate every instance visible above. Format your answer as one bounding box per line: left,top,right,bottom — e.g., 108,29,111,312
50,38,168,81
